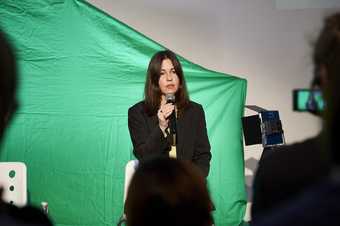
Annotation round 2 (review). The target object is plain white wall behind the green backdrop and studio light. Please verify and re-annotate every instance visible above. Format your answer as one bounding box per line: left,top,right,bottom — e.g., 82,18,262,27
89,0,340,203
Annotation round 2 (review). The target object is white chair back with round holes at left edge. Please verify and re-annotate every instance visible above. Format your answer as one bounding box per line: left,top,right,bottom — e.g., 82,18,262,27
0,162,27,207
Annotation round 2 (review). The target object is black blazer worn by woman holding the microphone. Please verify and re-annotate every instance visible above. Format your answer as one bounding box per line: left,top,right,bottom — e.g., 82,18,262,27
128,101,211,177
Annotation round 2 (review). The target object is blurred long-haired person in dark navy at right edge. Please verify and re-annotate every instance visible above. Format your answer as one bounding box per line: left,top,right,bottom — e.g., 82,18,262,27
253,12,340,226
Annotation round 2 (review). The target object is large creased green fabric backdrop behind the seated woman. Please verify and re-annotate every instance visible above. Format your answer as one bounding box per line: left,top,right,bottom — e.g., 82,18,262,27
0,0,247,226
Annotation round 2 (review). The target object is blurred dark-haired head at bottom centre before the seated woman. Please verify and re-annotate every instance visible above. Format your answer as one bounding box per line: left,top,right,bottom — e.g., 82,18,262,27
125,158,213,226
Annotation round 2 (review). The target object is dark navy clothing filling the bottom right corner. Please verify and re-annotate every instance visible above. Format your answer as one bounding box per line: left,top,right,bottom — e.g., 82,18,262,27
251,176,340,226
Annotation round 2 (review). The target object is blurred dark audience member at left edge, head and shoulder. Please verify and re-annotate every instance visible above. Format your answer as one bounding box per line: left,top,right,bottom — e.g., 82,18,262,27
0,30,52,226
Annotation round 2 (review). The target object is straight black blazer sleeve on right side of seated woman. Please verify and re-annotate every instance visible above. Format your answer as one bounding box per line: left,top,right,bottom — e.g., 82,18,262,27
192,105,211,177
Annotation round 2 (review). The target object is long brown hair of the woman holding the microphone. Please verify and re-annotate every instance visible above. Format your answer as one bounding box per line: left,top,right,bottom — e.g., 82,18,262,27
144,50,189,115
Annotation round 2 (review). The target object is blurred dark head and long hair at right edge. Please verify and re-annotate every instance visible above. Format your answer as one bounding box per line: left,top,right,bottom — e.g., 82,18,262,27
313,12,340,164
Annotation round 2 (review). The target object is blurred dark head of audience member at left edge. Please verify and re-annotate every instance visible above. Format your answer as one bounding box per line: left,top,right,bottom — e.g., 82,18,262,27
0,30,17,142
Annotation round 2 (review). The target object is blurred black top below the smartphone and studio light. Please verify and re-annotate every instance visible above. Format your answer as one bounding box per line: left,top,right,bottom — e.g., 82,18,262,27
252,137,330,221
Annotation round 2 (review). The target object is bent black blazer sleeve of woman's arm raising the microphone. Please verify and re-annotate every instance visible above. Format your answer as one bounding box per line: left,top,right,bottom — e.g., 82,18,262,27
128,107,170,160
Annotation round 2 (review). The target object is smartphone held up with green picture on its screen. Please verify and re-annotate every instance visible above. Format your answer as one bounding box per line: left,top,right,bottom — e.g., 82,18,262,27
293,89,325,112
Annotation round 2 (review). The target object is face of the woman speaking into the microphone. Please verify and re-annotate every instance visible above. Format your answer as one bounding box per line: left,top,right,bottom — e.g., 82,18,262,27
158,59,179,95
